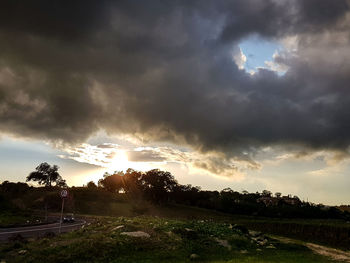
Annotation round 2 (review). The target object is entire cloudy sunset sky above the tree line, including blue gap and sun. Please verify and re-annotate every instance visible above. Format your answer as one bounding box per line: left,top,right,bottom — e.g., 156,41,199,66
0,0,350,205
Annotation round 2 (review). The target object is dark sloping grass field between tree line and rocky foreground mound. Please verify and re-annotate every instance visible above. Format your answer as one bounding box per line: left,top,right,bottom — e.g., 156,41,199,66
72,200,350,250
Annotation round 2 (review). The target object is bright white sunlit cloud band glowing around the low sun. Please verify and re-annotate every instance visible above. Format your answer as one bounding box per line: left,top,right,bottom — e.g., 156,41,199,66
59,143,254,178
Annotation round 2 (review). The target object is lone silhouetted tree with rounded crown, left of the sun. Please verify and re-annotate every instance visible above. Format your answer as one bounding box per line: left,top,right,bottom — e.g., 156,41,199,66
27,162,67,187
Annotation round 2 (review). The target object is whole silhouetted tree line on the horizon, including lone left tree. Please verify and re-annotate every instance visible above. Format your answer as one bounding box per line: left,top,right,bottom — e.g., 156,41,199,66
0,163,350,220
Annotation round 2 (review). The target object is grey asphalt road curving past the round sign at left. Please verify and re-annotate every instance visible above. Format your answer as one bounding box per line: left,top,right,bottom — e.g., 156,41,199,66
0,220,86,242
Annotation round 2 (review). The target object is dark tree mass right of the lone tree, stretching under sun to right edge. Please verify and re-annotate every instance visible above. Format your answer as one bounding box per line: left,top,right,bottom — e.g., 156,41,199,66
93,169,345,218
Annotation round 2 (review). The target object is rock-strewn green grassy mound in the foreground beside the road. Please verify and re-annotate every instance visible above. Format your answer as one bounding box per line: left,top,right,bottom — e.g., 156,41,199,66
0,216,331,263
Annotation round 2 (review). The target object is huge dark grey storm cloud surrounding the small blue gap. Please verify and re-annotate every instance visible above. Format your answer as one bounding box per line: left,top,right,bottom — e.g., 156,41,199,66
0,0,350,163
